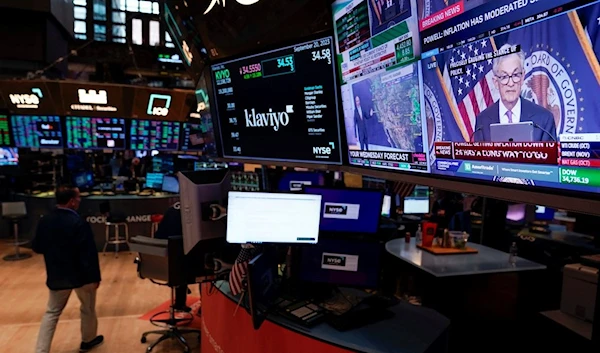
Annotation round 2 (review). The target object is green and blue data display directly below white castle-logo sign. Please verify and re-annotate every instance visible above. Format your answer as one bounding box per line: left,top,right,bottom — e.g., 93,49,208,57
66,117,126,149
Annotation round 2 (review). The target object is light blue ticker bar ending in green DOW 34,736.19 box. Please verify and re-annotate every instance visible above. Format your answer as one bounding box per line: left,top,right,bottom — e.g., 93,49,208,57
435,159,600,187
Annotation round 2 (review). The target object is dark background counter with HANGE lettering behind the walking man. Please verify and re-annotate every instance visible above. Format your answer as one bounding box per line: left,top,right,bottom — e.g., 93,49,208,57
16,193,179,250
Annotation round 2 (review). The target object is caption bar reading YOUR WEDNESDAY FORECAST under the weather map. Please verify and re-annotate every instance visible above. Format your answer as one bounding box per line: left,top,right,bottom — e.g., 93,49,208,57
350,150,427,171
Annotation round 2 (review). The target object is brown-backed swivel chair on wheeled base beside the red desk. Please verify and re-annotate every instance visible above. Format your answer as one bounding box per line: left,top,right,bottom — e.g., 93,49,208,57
130,236,201,353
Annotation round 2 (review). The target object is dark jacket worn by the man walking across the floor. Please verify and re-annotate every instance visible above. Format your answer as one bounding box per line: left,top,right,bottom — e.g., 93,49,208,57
32,208,101,290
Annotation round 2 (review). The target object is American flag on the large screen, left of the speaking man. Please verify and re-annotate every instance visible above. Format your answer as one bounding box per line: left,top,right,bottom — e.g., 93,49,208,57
444,38,500,138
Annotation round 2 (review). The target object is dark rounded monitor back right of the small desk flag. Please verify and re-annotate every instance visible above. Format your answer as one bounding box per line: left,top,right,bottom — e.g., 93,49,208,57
248,253,279,330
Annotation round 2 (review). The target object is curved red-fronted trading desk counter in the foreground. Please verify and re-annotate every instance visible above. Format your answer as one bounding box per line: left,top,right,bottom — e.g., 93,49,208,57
201,281,450,353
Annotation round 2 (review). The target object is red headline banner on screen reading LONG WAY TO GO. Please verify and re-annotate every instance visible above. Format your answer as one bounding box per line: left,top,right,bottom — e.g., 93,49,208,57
435,142,560,165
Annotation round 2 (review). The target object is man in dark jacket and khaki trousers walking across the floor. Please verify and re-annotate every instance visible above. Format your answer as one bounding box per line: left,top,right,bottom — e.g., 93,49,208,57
32,186,104,353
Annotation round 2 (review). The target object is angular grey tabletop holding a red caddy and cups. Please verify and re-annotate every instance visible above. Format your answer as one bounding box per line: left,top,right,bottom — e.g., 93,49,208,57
385,238,546,277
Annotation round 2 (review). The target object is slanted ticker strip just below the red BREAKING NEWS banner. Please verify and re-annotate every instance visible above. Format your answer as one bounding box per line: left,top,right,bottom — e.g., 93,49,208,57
421,0,596,58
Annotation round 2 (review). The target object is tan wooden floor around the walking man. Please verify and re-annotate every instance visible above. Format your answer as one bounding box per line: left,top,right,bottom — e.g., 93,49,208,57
0,243,199,353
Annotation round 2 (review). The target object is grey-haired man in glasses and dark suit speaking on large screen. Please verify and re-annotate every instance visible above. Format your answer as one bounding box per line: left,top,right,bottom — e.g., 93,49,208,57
473,44,557,141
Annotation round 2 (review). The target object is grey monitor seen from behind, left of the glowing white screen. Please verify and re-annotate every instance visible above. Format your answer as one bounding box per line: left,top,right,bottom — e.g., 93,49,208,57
177,169,231,255
